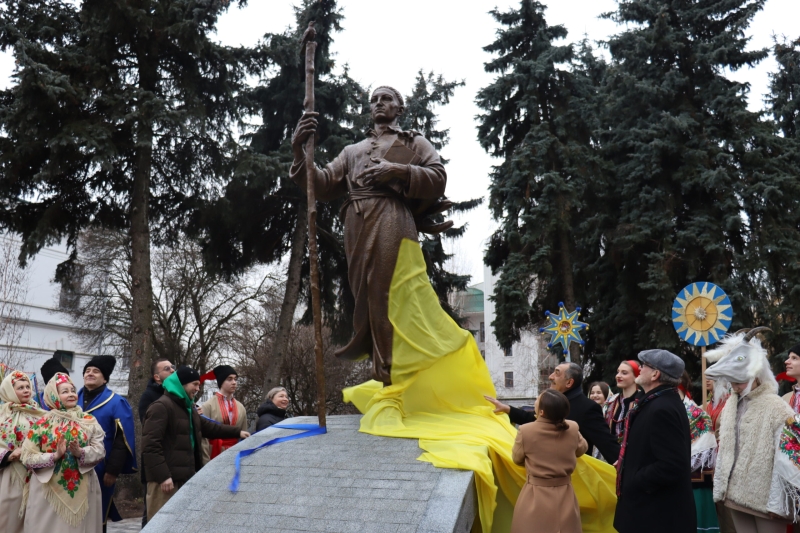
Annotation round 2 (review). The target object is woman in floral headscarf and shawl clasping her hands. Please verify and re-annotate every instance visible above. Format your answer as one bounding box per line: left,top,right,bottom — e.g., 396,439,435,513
22,372,105,533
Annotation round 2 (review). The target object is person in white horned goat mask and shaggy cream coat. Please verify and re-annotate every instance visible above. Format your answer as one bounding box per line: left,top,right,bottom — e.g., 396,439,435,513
706,328,794,533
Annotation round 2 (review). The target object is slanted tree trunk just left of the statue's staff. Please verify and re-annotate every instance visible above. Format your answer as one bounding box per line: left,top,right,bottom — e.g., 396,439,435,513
264,201,308,394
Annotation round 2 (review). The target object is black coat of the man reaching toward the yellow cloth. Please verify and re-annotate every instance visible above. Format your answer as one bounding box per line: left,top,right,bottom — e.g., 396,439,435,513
508,387,620,464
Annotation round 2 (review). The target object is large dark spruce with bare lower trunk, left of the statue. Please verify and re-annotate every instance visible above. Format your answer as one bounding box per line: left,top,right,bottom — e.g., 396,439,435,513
0,0,261,396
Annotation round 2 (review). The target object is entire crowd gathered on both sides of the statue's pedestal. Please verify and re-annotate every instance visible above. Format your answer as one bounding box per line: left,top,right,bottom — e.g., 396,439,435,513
0,328,800,533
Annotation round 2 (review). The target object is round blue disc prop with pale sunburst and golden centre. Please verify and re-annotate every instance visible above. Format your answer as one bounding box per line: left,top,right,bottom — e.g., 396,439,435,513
672,282,733,346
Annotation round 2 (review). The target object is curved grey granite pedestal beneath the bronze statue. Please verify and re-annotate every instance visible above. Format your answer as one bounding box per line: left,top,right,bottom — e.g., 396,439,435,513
142,416,477,533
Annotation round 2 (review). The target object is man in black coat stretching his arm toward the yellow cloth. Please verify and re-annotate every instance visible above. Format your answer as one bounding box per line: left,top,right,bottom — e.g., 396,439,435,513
485,363,620,464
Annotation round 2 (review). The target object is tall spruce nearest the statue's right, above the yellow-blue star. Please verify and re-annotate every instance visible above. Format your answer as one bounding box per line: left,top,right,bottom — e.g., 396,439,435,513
477,0,603,360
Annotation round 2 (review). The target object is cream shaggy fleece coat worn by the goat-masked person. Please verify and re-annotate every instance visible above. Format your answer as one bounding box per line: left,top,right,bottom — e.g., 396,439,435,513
714,383,794,514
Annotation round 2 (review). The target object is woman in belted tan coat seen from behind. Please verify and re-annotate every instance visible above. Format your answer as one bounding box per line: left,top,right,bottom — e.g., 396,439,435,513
511,389,588,533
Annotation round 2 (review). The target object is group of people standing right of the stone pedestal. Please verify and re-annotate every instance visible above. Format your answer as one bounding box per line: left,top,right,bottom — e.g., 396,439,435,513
486,328,800,533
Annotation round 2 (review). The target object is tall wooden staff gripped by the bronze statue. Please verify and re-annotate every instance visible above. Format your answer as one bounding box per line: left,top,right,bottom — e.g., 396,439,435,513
301,21,326,427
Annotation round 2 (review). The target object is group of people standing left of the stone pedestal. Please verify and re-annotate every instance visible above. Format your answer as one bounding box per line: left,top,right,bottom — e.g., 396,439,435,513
0,355,289,533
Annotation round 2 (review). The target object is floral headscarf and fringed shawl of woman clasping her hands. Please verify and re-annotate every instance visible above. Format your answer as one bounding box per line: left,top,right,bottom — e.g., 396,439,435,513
22,372,103,526
